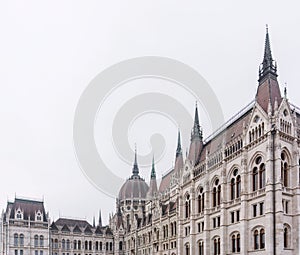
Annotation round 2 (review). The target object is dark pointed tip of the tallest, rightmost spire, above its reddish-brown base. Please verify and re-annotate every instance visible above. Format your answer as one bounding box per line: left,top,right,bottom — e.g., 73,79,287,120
259,25,277,82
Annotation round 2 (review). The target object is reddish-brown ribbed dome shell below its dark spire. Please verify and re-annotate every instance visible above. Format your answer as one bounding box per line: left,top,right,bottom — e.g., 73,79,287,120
119,175,149,201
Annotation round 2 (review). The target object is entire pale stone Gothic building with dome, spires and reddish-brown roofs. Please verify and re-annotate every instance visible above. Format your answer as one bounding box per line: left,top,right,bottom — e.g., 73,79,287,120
0,28,300,255
